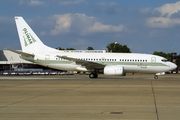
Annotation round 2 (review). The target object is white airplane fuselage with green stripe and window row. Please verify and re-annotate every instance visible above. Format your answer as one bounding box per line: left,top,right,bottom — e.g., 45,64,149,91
21,51,176,73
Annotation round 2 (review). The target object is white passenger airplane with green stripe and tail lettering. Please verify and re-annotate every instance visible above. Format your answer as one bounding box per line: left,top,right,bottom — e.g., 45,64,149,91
9,16,177,79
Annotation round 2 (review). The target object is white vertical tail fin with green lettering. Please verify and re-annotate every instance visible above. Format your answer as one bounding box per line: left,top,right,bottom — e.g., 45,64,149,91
15,17,57,54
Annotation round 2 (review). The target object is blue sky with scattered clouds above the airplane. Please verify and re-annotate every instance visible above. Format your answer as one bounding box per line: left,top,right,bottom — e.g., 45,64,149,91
0,0,180,54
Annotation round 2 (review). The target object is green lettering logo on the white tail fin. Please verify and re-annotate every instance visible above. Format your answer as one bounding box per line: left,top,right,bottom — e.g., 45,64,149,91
22,28,36,46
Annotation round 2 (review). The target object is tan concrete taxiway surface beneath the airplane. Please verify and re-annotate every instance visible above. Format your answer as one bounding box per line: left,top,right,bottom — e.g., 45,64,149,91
0,74,180,120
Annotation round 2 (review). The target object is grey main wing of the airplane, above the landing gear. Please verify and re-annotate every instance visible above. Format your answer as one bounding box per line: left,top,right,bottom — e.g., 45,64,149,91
57,55,105,69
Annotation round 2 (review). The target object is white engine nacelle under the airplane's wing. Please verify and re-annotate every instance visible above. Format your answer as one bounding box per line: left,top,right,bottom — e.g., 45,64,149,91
104,65,125,76
